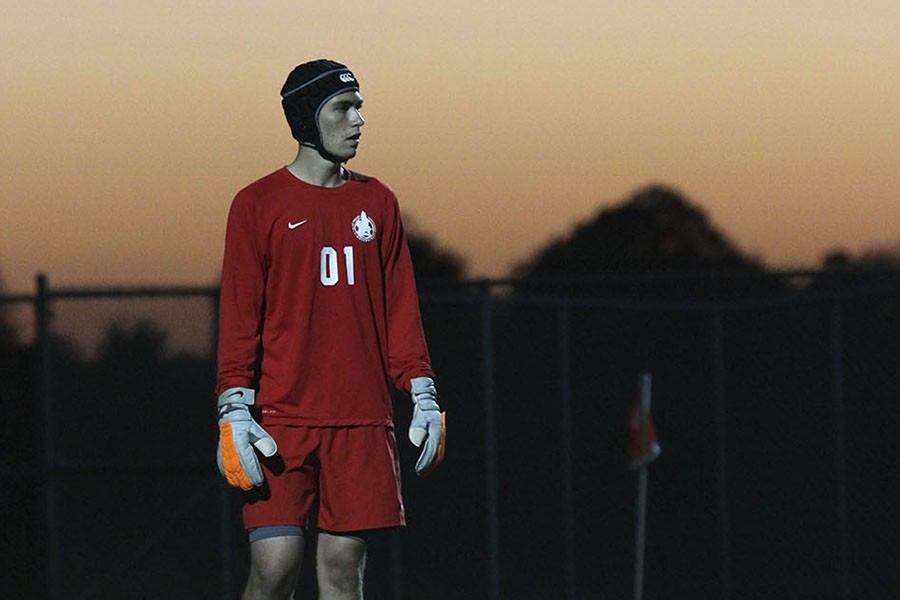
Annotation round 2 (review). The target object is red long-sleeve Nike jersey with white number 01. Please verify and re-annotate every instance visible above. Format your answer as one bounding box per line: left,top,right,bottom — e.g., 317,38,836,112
216,168,434,427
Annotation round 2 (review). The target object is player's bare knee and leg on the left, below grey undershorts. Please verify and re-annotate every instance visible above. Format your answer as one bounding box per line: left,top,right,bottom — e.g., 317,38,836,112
241,535,303,600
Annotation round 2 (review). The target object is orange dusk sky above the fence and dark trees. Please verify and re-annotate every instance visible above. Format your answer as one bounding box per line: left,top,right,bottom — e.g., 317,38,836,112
0,0,900,292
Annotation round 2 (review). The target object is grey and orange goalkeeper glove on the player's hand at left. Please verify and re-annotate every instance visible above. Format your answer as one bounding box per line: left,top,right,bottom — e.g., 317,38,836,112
217,388,278,490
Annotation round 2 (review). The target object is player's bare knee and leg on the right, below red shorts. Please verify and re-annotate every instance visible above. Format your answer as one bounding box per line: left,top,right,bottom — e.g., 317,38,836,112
316,531,366,600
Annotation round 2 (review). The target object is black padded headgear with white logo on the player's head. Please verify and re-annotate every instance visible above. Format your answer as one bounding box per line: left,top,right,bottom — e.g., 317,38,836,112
281,59,359,163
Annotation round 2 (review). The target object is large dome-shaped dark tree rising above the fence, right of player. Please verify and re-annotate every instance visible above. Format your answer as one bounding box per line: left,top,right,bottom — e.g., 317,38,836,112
514,186,773,298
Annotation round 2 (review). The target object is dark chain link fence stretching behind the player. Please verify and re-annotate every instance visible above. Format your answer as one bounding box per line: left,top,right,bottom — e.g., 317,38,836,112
0,271,900,600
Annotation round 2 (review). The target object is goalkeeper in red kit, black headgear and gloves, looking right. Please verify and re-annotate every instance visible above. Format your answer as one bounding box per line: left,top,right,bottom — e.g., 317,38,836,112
216,60,444,600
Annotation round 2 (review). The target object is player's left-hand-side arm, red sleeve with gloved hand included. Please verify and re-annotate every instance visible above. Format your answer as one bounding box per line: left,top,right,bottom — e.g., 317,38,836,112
216,194,277,490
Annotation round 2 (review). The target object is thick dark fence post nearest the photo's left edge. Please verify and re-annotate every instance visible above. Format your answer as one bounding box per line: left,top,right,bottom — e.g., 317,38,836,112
34,273,62,600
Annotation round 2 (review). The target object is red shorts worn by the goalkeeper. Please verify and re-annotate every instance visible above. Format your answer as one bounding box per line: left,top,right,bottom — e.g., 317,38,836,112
243,424,406,533
